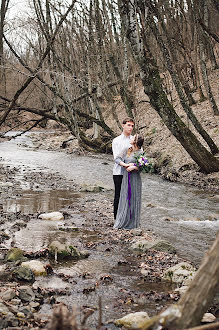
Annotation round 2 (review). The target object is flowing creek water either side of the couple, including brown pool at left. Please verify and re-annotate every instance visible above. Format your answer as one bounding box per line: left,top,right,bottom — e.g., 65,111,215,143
0,133,219,264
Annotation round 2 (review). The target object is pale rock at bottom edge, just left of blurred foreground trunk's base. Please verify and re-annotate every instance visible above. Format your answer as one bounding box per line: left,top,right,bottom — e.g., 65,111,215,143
114,312,150,329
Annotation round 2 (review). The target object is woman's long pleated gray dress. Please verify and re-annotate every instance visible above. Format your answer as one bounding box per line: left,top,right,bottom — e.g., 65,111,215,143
114,151,142,229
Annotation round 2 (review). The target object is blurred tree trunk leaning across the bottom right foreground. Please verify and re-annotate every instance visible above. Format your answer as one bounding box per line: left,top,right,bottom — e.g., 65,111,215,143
142,233,219,330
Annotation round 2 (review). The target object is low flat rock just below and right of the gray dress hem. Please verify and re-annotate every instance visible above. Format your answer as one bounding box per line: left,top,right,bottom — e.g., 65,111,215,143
131,238,176,254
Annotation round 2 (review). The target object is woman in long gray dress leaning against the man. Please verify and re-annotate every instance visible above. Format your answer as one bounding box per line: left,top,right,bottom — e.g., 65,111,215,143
114,134,144,229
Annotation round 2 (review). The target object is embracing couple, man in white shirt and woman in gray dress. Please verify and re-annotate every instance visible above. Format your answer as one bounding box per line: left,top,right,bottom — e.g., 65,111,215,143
112,118,144,229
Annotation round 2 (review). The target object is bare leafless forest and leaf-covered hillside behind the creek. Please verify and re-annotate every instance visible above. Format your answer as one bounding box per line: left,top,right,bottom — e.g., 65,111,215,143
0,0,219,186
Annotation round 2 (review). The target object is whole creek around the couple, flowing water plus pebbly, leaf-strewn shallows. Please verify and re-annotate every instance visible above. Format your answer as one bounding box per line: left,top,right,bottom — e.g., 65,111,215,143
0,133,218,329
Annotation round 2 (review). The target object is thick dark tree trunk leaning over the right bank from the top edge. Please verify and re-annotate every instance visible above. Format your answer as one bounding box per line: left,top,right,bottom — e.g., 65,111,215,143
118,0,219,173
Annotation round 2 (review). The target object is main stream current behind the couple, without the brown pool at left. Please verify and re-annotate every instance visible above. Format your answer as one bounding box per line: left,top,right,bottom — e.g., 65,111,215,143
0,132,219,265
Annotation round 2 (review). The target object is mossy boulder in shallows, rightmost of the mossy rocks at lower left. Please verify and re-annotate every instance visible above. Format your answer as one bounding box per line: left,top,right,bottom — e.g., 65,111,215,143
49,241,81,259
